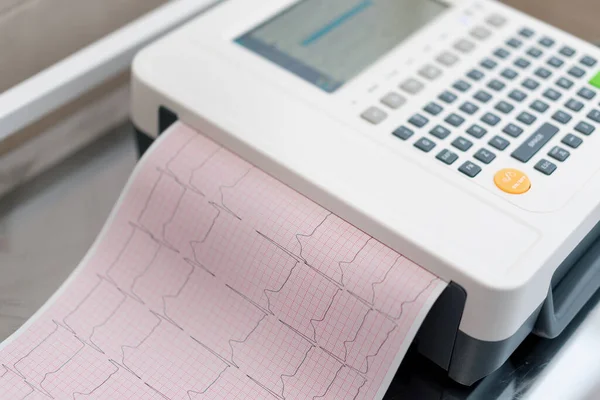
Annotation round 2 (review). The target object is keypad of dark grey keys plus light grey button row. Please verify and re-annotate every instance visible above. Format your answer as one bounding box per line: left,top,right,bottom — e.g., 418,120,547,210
362,16,600,182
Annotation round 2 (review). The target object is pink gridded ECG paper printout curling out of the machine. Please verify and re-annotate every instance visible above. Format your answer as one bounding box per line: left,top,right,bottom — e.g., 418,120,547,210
0,123,446,400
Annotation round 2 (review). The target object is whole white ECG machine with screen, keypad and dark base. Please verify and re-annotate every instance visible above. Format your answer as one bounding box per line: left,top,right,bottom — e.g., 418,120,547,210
132,0,600,385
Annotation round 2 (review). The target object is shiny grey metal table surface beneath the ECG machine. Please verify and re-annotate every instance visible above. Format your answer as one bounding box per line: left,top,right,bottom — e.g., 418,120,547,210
0,122,600,400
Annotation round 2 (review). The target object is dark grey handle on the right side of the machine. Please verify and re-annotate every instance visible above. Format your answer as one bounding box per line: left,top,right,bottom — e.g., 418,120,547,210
534,239,600,338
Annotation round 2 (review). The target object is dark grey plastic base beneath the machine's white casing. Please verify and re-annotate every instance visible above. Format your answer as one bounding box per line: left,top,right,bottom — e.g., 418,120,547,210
135,107,600,390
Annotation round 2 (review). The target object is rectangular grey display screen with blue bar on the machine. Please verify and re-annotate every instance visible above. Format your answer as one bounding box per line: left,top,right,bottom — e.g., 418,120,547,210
236,0,447,92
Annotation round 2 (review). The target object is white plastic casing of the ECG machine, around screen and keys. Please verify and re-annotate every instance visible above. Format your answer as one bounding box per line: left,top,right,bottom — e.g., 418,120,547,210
132,0,600,341
